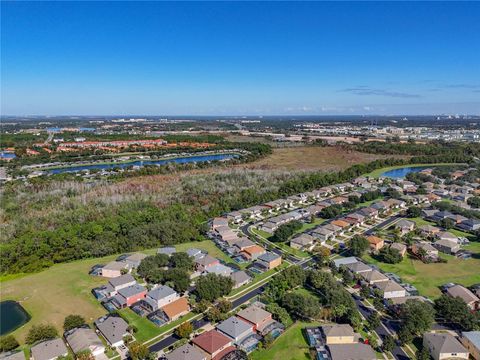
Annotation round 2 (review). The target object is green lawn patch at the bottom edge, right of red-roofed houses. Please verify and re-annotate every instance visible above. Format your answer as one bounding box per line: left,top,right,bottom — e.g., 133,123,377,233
250,322,319,360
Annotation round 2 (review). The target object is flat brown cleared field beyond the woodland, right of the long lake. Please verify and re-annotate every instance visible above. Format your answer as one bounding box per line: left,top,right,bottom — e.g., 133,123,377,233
235,146,395,171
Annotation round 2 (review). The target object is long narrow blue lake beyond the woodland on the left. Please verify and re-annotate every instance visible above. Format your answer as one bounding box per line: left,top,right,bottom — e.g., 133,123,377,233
46,154,239,174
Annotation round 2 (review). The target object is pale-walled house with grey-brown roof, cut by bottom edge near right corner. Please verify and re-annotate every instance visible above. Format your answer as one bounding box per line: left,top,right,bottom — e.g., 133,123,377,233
423,333,469,360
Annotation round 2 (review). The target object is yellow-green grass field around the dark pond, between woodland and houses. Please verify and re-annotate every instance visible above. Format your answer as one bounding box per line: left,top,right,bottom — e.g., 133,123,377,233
0,240,232,342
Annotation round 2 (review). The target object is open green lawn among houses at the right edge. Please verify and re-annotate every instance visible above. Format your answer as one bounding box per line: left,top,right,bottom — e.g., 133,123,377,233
363,250,480,298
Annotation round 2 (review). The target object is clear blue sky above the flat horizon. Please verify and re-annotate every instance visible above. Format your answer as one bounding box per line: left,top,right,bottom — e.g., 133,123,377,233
1,1,480,115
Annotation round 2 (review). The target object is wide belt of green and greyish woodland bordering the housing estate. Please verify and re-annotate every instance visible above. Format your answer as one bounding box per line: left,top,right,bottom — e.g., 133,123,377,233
0,140,473,273
